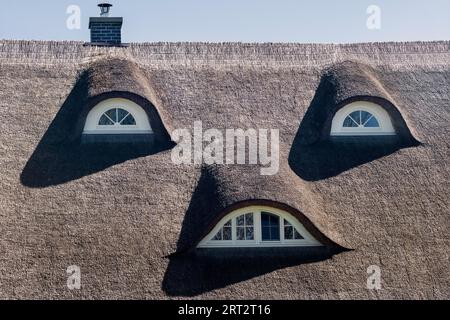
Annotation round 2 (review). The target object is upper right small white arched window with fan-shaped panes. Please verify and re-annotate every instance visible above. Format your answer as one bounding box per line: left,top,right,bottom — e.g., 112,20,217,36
330,101,396,136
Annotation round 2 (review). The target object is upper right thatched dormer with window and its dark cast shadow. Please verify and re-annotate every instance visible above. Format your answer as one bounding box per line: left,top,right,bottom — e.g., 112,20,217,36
289,61,420,181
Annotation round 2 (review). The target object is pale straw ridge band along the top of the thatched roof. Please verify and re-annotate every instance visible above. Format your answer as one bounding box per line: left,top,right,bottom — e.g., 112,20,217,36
0,40,450,67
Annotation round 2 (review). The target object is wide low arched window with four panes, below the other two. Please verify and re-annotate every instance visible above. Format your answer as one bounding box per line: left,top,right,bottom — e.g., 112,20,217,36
198,206,322,248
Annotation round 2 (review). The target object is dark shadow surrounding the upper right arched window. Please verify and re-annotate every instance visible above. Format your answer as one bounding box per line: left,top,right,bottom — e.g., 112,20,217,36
289,66,420,181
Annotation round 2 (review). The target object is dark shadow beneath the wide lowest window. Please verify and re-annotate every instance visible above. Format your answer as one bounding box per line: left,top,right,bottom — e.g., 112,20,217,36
162,247,342,297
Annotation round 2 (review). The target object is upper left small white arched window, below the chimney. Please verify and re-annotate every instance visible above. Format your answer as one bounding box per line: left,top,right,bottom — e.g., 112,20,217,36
83,98,152,135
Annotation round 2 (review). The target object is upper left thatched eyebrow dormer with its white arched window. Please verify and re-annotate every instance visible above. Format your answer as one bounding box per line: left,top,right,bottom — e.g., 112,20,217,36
75,59,173,149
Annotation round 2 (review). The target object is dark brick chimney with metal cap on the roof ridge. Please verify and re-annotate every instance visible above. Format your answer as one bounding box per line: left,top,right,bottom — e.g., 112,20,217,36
89,2,123,46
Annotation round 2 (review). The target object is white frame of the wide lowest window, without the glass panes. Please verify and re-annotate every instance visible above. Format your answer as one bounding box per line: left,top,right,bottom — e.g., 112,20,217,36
197,206,323,248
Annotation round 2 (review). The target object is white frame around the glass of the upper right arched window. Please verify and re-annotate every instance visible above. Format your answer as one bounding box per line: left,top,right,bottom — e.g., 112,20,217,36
330,101,396,136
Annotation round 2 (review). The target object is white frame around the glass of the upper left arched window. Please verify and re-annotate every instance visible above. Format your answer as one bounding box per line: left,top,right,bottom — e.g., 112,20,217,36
83,98,153,134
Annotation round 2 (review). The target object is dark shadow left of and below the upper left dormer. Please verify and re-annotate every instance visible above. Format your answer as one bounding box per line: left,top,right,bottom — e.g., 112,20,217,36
20,73,172,188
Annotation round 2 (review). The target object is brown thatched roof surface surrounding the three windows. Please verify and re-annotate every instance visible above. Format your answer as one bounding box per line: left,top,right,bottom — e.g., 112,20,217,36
0,41,450,299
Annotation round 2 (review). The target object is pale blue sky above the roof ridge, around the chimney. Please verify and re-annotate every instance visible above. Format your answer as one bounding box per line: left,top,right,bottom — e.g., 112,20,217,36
0,0,450,43
